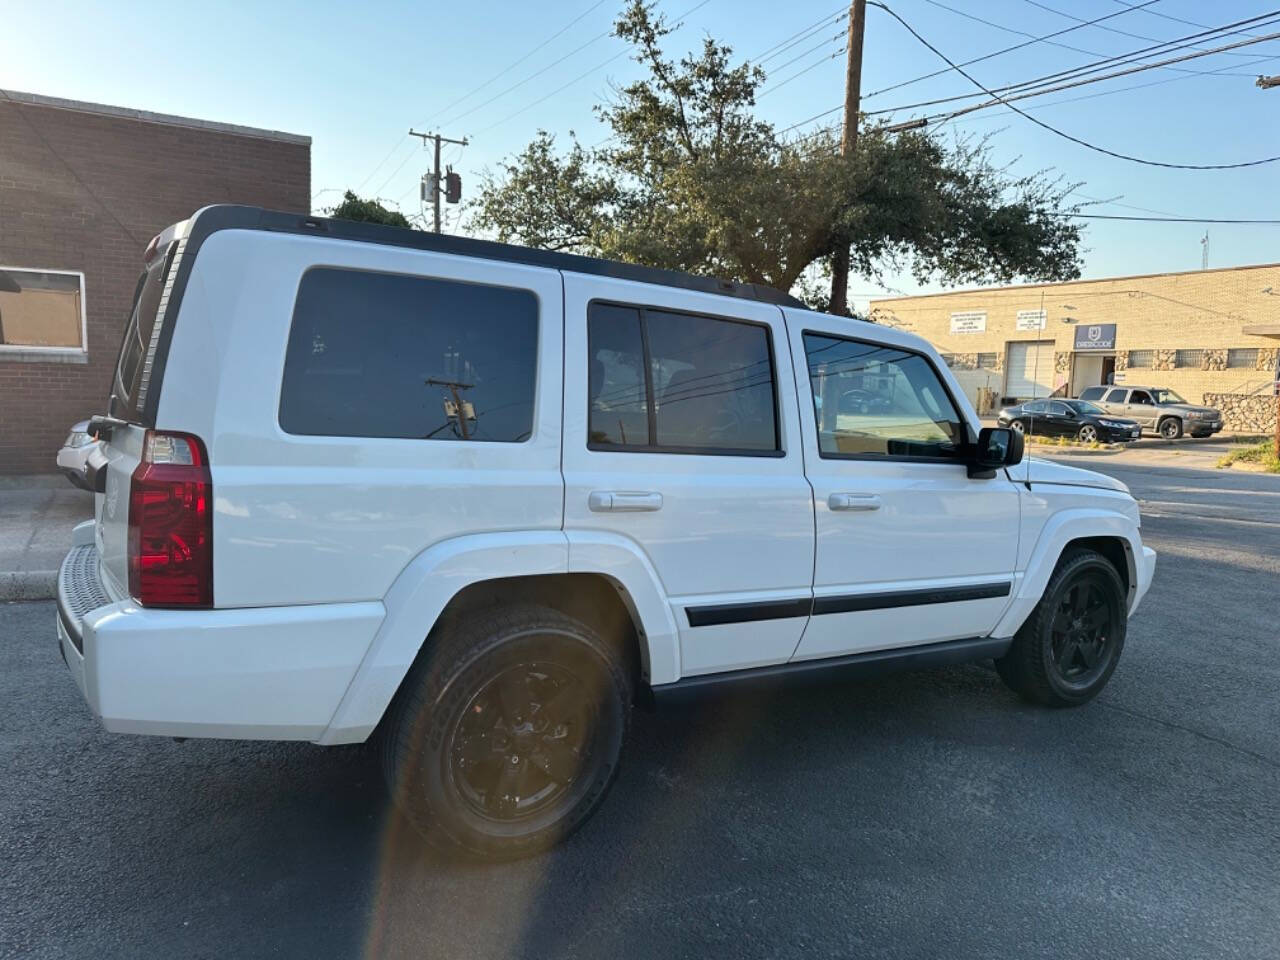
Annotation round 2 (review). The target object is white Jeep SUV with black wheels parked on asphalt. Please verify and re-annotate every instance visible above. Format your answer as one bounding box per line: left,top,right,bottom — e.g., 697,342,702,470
58,206,1156,858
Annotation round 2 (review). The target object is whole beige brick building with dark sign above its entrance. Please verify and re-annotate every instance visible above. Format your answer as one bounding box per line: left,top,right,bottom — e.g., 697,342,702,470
870,264,1280,429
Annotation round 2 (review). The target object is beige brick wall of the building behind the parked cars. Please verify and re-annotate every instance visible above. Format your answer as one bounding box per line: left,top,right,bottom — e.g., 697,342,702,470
870,264,1280,402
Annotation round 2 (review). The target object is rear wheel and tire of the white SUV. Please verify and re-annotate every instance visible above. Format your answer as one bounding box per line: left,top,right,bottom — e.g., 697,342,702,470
381,604,631,860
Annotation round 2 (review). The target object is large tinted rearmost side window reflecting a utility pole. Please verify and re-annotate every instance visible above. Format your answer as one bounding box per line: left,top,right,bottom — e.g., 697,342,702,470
280,268,538,443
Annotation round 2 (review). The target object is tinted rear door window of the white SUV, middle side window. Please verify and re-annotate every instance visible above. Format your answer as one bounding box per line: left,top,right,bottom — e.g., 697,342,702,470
588,303,780,454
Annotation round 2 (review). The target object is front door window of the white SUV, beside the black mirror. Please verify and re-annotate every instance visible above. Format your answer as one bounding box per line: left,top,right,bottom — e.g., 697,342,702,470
804,333,966,458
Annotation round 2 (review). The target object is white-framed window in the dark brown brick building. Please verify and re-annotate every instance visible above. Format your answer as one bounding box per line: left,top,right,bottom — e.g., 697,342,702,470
0,266,84,353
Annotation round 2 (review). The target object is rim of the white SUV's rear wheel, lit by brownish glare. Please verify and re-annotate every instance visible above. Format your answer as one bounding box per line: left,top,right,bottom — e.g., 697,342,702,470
448,662,595,822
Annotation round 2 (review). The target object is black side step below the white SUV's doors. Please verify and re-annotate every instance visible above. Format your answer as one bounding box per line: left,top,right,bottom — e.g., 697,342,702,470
645,636,1012,705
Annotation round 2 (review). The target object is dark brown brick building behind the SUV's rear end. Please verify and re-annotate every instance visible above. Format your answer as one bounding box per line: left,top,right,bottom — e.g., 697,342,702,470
0,91,311,474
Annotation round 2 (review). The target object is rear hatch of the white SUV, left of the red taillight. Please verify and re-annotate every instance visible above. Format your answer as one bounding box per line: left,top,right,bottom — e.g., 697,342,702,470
95,221,187,595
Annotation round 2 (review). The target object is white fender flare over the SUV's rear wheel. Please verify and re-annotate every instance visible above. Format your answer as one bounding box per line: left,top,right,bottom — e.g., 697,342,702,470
315,530,680,745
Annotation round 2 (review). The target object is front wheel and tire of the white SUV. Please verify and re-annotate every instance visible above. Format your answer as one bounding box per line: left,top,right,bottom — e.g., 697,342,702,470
996,549,1128,707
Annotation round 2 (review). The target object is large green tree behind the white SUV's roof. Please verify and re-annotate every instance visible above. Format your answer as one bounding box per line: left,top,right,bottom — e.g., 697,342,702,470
472,0,1080,305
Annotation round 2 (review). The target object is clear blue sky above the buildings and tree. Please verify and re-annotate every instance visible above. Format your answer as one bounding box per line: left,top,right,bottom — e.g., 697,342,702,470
0,0,1280,308
